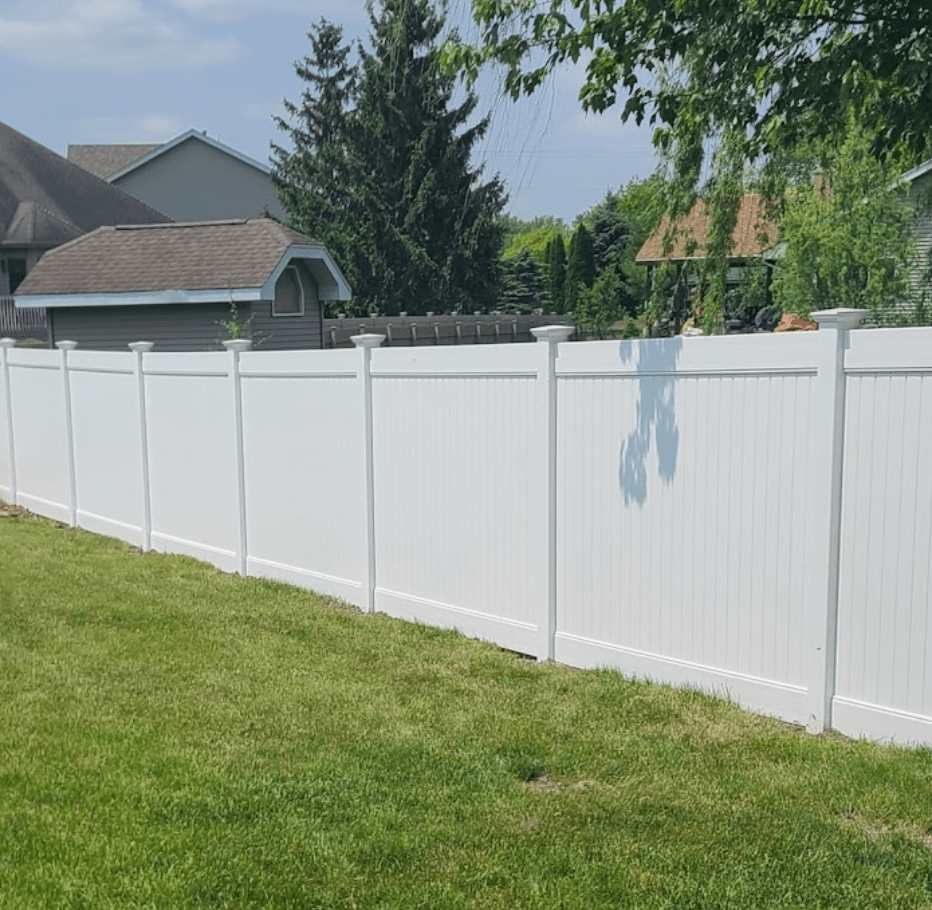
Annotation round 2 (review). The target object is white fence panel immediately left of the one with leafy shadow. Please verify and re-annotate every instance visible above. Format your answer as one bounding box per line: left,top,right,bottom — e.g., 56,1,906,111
371,344,549,657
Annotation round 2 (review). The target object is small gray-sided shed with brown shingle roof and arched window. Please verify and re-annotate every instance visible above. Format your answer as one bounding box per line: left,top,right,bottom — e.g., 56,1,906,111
15,218,351,351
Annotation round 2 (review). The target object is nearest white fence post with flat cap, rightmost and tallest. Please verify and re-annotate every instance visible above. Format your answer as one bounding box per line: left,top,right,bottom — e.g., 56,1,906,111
806,309,867,733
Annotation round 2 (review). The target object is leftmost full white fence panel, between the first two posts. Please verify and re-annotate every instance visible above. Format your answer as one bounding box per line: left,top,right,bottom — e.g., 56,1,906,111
7,349,71,523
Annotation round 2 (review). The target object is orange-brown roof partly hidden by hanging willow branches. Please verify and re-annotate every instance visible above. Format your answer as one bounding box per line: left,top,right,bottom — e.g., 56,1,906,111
637,193,779,264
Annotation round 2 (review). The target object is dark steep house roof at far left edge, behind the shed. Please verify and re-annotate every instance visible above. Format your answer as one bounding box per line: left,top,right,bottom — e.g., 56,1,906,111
0,123,169,247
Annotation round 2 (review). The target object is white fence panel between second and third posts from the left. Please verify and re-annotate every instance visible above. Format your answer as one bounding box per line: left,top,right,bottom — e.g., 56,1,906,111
68,351,143,546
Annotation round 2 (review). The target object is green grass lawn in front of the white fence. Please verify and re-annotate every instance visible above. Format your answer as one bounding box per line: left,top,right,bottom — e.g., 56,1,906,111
0,509,932,910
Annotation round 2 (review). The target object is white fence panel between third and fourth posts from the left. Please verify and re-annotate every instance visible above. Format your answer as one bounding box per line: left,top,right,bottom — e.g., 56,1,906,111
143,352,239,572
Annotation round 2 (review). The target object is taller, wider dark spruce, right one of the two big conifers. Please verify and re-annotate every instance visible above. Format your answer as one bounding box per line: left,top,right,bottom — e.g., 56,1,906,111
353,0,505,313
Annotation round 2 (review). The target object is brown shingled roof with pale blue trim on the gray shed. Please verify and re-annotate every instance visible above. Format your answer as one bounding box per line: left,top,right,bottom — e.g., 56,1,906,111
16,218,351,307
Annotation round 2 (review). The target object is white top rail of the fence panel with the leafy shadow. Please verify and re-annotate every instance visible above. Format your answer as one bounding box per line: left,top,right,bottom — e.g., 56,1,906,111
557,332,818,377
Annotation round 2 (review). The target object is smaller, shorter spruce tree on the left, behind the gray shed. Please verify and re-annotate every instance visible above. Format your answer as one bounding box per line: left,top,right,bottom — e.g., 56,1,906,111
272,18,357,282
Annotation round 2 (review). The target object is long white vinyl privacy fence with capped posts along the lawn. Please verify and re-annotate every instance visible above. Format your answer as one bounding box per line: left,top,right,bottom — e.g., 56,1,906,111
0,310,932,743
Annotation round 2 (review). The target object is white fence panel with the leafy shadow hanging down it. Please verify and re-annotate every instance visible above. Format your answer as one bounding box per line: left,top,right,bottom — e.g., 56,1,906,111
556,336,816,721
